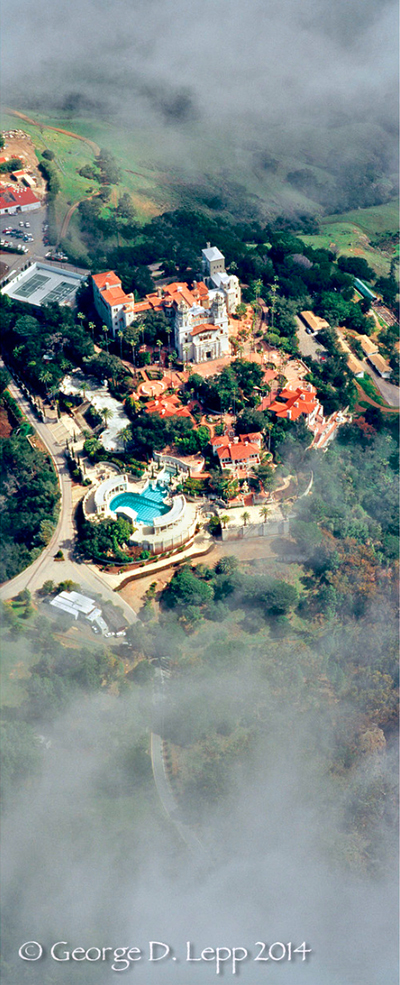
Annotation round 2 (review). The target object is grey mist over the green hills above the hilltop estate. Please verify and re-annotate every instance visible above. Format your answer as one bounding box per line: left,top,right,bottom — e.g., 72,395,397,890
3,0,397,211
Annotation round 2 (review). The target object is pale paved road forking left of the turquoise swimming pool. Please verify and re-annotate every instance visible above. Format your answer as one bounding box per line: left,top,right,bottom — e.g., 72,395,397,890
0,368,137,623
